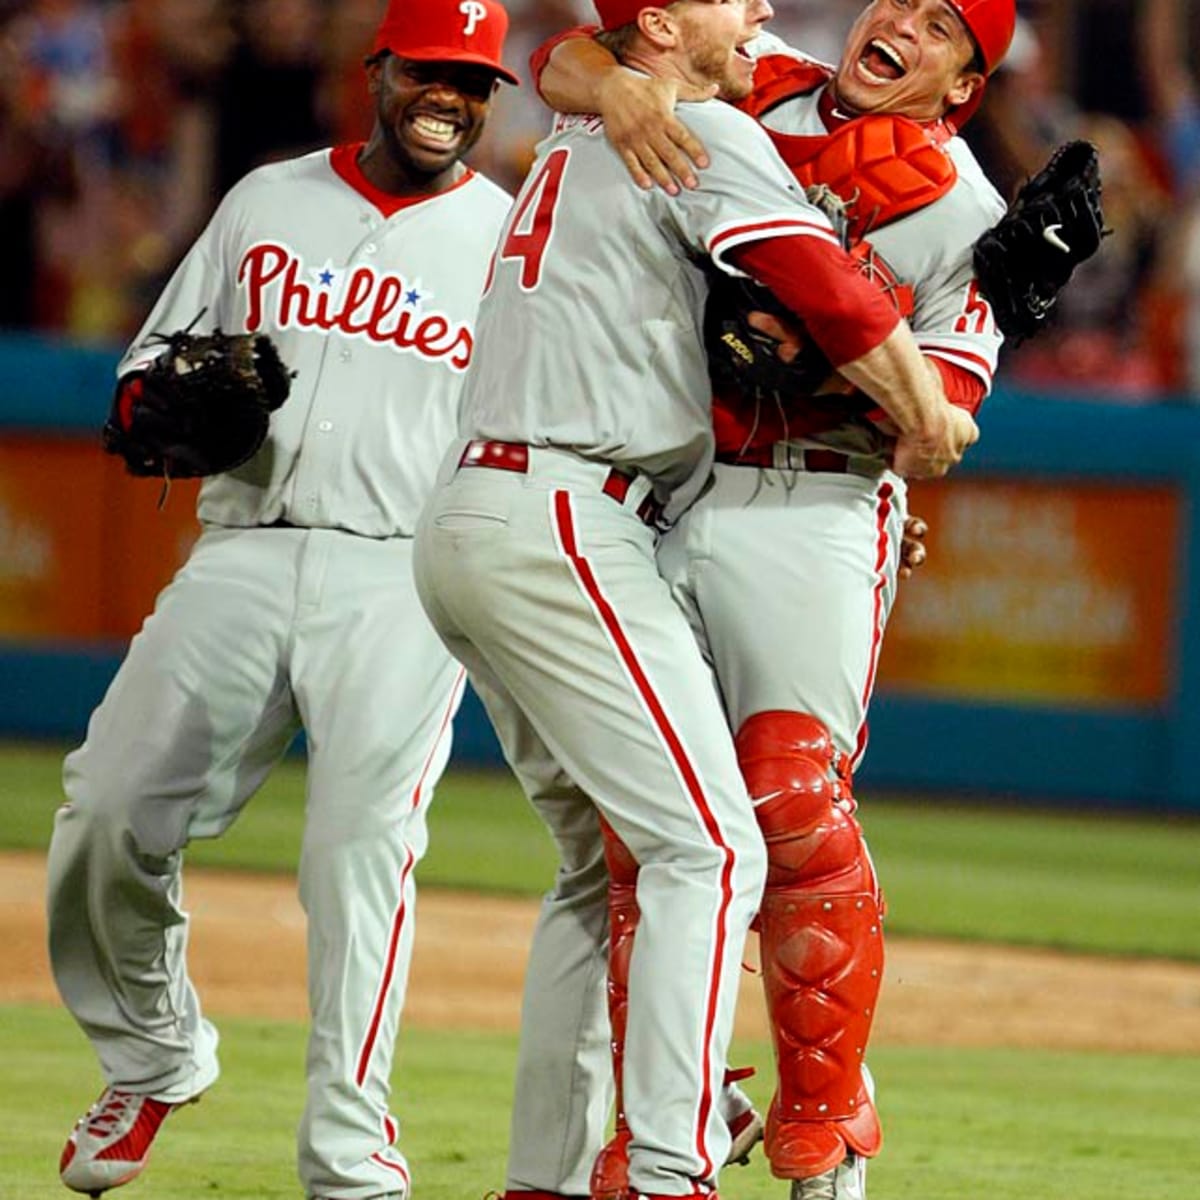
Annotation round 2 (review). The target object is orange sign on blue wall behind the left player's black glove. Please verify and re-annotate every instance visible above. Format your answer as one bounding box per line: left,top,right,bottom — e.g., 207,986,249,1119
0,436,199,641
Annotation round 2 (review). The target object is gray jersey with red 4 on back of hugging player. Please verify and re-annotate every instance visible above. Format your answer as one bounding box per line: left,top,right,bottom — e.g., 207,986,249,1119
461,100,836,510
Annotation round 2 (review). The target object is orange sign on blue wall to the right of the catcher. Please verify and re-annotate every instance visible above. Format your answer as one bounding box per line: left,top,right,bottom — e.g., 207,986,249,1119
878,480,1181,707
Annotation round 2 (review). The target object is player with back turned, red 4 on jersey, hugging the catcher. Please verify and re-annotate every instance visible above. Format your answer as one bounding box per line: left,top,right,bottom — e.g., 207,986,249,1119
416,0,974,1196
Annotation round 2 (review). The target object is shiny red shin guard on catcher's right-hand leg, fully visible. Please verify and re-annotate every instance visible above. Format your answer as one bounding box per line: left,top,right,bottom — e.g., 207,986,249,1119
737,713,883,1178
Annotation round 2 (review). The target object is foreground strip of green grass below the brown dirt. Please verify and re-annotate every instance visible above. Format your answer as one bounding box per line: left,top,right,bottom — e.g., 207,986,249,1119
0,1008,1200,1200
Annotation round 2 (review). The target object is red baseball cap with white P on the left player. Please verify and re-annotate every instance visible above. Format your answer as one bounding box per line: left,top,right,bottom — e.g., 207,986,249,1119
372,0,521,84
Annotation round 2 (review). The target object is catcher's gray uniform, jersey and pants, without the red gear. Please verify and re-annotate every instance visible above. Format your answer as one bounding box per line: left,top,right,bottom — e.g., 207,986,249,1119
659,34,1004,766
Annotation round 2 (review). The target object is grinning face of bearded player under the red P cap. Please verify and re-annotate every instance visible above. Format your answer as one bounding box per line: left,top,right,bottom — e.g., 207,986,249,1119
359,54,497,192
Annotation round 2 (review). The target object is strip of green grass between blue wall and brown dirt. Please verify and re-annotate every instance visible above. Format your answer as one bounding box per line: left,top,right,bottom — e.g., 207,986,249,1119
0,745,1200,960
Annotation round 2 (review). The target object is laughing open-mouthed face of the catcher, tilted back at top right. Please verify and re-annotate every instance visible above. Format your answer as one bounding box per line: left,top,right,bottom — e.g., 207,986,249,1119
834,0,984,121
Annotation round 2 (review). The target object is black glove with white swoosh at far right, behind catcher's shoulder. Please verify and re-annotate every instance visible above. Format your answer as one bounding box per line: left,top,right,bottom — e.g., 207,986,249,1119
974,142,1105,343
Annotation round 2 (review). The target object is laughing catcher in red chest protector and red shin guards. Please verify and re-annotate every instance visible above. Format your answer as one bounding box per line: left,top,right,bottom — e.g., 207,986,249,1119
516,0,1015,1200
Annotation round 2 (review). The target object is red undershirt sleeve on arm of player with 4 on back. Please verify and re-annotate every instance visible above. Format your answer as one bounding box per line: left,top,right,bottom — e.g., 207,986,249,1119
726,236,900,367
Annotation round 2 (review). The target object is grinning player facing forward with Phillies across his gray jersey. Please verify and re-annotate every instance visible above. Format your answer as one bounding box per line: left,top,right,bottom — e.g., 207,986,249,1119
49,0,516,1200
